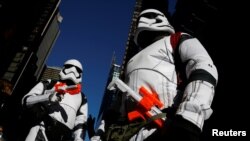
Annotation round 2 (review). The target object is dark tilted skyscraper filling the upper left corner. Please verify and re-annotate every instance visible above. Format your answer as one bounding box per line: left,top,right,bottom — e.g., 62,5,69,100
0,0,61,97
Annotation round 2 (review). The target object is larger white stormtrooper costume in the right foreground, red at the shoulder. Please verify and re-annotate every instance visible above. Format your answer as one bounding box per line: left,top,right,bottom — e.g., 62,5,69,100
124,9,218,141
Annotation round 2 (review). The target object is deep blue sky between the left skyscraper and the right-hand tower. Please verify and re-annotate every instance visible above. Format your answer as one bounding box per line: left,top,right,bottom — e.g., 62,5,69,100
47,0,176,139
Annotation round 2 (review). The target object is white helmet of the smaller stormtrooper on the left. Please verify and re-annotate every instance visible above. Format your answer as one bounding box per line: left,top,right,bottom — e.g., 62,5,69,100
59,59,83,84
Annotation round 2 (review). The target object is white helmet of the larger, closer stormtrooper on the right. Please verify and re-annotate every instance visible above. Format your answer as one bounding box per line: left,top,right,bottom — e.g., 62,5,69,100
134,9,175,45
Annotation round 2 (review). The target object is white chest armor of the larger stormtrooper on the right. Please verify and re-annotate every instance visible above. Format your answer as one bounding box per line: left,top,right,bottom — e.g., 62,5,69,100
125,37,177,107
